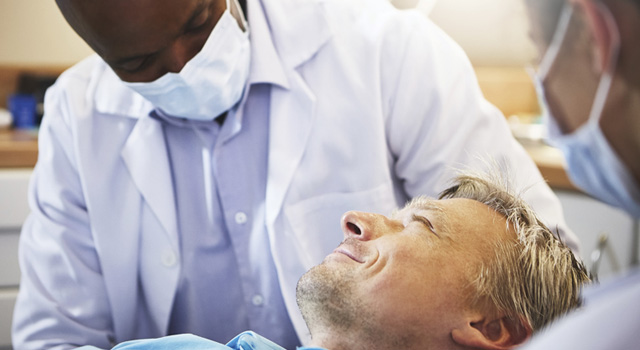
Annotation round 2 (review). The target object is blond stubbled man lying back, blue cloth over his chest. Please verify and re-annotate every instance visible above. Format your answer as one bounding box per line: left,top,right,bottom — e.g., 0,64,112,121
84,174,588,350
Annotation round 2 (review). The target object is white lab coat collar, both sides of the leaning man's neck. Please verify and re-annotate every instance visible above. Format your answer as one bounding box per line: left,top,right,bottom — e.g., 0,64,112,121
88,0,331,118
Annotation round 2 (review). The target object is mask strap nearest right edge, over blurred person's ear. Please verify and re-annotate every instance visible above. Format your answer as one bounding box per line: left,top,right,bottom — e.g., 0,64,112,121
588,3,620,127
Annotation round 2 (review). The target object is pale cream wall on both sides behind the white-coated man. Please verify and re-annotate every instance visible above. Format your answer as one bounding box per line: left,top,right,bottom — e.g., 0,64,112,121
0,0,533,66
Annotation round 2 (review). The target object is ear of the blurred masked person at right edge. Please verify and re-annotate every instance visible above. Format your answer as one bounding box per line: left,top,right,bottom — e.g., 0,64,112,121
573,0,620,74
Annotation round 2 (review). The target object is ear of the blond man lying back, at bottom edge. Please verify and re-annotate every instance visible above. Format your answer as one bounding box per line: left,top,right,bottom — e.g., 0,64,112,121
451,317,532,349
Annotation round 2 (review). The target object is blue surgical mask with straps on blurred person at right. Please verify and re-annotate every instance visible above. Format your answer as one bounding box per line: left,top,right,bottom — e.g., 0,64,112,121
532,3,640,217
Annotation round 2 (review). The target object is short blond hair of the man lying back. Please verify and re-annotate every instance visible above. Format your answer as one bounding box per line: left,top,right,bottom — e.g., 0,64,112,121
439,172,589,333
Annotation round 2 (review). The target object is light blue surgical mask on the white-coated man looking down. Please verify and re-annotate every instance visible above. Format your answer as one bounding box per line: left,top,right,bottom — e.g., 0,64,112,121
124,0,250,120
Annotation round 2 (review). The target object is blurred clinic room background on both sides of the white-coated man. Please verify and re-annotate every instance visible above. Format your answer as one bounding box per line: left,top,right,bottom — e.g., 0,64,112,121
0,0,640,350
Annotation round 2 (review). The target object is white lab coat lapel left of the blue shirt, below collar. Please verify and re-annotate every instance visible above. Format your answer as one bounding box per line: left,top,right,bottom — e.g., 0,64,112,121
121,115,178,248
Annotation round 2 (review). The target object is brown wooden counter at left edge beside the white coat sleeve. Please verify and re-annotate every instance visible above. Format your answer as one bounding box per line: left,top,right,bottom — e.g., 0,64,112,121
0,129,38,168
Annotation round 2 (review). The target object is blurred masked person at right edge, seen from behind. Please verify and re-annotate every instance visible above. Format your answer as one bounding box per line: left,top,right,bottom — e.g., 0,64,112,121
526,0,640,349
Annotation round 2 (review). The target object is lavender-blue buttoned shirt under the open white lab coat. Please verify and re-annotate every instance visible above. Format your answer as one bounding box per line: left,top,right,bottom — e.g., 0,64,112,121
160,0,300,349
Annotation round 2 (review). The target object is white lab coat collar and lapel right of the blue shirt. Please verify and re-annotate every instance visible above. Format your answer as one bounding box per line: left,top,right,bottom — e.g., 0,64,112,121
260,0,331,227
